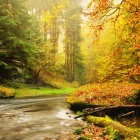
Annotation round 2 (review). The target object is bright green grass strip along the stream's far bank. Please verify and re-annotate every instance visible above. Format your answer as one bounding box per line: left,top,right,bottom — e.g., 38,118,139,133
15,87,76,98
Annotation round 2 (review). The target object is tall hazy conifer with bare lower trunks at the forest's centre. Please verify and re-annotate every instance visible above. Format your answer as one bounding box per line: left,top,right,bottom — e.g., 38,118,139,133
65,0,85,84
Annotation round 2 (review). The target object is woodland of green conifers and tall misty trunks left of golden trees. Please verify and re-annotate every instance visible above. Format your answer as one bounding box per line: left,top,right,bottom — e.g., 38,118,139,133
0,0,85,84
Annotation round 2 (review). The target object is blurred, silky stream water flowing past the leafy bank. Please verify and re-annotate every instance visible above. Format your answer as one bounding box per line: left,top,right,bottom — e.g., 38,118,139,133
0,96,84,140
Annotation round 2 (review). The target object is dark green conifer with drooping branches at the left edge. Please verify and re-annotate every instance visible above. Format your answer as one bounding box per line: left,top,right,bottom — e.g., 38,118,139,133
0,0,32,79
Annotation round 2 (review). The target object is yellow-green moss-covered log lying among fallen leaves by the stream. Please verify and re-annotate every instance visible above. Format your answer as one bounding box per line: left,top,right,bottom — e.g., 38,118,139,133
86,116,140,139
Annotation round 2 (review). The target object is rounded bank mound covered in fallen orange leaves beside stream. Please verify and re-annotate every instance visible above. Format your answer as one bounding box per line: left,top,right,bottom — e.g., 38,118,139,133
67,83,140,106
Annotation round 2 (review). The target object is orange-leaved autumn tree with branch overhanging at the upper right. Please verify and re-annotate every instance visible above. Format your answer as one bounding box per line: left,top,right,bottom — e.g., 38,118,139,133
84,0,140,82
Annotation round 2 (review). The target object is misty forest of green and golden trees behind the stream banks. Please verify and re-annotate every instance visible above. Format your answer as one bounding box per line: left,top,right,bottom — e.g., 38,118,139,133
0,0,140,85
